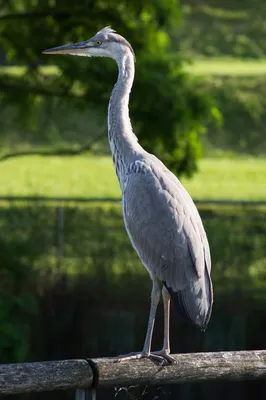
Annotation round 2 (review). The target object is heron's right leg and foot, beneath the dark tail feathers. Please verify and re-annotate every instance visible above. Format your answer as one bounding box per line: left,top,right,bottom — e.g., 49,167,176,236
153,286,176,364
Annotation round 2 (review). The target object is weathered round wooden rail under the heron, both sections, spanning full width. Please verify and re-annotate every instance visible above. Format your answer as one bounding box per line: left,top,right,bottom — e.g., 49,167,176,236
0,350,266,395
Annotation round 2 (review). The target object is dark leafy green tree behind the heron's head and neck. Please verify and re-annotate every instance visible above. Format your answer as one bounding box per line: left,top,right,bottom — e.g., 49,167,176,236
0,0,218,175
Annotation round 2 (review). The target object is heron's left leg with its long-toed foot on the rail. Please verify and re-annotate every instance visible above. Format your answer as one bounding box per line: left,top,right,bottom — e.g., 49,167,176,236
114,276,162,362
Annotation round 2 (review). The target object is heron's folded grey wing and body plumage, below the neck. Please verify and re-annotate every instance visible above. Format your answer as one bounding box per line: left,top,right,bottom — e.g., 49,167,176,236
123,160,212,328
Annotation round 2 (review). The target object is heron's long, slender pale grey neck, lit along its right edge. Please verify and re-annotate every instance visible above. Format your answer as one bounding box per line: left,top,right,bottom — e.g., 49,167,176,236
108,49,142,188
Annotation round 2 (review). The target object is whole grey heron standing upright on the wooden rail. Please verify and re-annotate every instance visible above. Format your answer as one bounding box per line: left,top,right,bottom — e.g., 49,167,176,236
44,27,213,363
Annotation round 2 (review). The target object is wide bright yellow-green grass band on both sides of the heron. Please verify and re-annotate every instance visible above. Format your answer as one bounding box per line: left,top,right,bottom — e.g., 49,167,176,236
0,156,266,200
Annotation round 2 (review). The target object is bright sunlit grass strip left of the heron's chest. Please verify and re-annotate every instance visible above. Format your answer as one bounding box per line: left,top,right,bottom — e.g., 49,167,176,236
0,156,119,197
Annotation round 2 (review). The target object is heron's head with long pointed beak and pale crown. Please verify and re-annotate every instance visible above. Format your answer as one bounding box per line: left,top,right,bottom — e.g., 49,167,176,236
43,27,134,60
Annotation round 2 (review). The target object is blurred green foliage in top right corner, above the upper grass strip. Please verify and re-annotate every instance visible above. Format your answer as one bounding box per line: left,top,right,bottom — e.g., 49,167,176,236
175,0,266,59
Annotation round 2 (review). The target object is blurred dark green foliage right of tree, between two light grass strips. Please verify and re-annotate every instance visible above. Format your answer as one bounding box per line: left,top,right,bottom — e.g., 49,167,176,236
198,76,266,156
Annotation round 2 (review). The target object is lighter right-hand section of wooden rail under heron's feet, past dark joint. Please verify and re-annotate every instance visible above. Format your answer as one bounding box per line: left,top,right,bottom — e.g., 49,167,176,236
93,350,266,387
